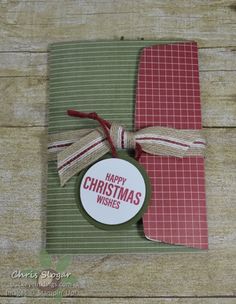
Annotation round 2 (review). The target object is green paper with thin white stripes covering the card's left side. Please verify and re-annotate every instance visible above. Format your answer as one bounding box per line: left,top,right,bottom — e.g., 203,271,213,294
46,40,196,254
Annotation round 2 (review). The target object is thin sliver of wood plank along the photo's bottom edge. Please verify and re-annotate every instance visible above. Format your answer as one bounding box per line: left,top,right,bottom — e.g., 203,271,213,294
1,297,235,304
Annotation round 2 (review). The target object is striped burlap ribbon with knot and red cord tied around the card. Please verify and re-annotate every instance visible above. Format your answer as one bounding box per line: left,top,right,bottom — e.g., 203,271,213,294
48,110,206,186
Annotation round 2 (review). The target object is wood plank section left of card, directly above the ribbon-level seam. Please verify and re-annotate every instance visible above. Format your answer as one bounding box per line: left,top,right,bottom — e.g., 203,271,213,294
0,77,47,126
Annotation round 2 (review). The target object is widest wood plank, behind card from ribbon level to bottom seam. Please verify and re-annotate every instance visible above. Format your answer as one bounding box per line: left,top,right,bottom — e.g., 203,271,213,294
0,128,236,297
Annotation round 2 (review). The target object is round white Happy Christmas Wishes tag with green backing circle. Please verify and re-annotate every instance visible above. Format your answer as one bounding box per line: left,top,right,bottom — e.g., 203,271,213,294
76,153,150,229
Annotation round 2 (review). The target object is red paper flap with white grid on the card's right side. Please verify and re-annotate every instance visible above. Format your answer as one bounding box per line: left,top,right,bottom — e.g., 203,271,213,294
135,42,208,249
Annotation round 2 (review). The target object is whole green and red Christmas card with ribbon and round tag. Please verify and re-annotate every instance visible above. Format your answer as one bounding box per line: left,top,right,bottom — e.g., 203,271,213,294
46,40,208,254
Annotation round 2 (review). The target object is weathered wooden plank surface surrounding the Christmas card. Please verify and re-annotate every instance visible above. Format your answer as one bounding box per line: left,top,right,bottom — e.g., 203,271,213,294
0,0,236,304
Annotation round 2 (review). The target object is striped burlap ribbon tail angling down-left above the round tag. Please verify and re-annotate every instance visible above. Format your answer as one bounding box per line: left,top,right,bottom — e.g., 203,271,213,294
57,130,110,186
